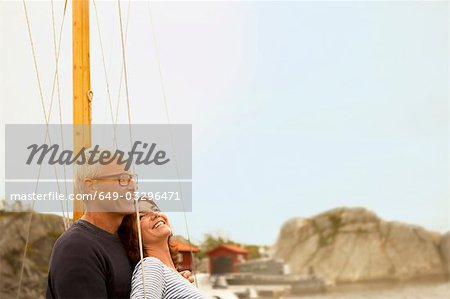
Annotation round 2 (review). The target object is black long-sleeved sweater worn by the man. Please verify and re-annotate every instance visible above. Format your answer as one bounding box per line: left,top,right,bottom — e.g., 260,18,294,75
46,219,132,299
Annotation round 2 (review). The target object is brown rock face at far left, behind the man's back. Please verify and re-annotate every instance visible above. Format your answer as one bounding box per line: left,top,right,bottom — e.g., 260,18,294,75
0,212,64,299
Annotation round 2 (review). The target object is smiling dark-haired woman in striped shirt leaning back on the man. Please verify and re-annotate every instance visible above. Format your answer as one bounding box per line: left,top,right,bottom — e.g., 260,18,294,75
119,201,206,299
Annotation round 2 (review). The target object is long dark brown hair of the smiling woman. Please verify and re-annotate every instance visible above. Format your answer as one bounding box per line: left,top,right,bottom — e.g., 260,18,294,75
118,213,178,268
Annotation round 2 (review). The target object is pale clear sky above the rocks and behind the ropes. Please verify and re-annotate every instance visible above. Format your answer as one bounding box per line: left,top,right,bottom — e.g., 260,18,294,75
0,1,450,244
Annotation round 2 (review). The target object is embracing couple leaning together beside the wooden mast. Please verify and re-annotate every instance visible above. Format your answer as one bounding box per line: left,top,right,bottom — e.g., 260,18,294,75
46,154,205,299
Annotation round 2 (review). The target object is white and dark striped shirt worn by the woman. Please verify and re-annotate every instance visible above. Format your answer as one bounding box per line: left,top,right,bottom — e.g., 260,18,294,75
130,257,206,299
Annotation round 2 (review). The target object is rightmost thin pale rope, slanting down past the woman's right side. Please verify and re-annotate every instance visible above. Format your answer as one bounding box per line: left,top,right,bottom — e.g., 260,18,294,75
147,2,198,288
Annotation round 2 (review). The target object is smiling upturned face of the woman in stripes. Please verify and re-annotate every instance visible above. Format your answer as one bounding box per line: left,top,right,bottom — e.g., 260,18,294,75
139,212,172,245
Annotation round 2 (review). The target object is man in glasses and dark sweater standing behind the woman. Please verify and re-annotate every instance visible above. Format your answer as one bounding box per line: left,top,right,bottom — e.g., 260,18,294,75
46,151,193,298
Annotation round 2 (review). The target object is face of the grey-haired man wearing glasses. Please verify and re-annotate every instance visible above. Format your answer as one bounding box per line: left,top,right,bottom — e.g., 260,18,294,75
88,162,137,215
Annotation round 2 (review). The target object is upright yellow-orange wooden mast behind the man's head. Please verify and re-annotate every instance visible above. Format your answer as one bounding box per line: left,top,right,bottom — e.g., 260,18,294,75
72,0,93,221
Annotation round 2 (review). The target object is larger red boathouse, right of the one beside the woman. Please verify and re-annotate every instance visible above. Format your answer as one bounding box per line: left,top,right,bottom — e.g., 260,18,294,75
206,244,249,274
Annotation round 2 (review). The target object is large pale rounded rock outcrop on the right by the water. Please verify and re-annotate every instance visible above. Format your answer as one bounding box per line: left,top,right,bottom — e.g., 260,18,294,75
275,208,449,282
